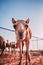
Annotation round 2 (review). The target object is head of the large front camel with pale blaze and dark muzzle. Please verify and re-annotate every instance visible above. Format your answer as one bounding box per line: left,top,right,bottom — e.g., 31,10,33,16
12,18,28,40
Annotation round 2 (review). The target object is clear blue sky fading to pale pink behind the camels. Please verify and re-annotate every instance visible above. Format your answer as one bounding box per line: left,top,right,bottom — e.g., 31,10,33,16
0,0,43,49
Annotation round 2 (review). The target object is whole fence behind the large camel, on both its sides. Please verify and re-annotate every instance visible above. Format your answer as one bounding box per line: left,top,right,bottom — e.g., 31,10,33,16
0,27,43,50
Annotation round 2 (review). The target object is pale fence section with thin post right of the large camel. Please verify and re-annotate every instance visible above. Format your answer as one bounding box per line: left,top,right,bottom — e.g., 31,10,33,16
30,36,43,50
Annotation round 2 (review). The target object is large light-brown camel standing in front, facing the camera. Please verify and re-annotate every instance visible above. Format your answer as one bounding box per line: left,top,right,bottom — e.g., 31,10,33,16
12,18,32,65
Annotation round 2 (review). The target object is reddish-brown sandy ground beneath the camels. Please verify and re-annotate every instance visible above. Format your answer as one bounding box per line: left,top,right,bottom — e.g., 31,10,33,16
0,51,43,65
